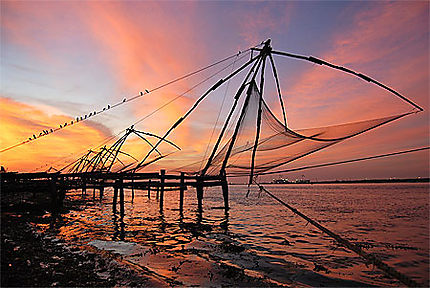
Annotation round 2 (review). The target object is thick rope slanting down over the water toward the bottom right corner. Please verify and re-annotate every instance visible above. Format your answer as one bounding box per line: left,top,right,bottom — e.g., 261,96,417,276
254,180,420,287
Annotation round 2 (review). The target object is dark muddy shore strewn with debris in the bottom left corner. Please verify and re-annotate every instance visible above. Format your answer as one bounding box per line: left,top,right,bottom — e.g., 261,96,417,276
1,202,164,287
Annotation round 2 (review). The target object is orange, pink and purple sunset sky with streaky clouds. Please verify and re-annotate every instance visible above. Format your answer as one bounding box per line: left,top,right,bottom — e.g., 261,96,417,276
0,1,429,179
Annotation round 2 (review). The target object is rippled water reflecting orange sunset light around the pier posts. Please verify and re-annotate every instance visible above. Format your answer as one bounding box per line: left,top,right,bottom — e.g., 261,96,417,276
37,184,429,286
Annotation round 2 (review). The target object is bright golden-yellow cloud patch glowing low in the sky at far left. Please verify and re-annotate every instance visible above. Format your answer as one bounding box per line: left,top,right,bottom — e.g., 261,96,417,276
0,98,108,171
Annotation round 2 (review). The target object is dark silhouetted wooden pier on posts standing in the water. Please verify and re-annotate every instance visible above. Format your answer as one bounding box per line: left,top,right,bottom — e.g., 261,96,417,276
0,170,229,215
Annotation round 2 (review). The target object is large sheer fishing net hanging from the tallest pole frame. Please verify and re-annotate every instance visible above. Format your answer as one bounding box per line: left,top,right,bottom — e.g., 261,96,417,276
206,81,407,176
